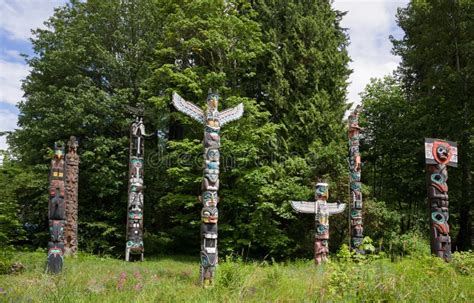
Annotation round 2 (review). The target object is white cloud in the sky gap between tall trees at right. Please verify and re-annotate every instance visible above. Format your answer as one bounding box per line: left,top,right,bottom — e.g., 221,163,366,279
333,0,408,103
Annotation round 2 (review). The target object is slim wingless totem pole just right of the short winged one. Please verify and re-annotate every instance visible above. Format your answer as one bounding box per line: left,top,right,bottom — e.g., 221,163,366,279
348,106,364,252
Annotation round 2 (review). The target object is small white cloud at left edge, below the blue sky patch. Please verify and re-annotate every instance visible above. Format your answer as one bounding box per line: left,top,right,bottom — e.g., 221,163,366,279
0,59,29,104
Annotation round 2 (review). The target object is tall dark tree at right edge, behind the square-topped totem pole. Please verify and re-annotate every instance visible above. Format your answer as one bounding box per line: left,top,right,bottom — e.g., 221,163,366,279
393,0,474,250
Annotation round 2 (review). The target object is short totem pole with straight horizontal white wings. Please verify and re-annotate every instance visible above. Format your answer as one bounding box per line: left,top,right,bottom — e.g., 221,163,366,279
291,183,346,265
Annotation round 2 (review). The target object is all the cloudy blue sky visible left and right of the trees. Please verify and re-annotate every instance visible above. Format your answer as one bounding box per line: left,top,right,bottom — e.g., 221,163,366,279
0,0,408,150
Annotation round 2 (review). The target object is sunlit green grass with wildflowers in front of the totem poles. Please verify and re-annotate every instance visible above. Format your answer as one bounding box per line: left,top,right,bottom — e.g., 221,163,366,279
0,252,474,303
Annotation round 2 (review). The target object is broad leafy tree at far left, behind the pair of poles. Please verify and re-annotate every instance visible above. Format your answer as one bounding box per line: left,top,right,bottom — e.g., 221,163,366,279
9,0,169,254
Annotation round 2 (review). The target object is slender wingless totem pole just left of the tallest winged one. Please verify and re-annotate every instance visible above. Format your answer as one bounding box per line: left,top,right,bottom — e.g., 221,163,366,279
125,116,145,261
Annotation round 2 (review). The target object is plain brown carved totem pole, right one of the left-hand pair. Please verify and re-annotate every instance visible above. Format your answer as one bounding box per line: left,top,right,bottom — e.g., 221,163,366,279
64,136,79,255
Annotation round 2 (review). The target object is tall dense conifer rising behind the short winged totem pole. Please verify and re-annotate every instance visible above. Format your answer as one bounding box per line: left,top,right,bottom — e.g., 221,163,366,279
251,0,350,254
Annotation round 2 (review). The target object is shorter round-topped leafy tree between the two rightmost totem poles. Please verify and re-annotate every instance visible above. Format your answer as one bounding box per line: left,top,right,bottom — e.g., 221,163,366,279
361,76,427,233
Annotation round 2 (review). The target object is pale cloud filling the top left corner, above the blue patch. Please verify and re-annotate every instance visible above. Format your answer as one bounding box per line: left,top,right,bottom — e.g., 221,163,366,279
0,0,64,40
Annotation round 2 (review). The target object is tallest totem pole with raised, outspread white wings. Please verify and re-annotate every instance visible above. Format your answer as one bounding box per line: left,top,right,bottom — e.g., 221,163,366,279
173,93,244,287
